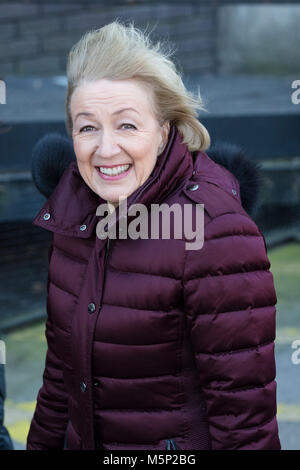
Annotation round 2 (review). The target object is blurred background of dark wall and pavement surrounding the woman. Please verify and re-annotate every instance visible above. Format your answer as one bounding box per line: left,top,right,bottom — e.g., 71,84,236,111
0,0,300,450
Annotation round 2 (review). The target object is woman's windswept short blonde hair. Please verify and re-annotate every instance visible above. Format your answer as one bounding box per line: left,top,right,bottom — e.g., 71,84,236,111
66,19,210,151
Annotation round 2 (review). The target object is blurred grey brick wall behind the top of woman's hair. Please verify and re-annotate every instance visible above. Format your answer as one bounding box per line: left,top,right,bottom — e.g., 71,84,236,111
0,0,217,78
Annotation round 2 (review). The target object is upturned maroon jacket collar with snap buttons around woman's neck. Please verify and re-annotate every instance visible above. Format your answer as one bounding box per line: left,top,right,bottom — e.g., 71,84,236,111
33,125,194,238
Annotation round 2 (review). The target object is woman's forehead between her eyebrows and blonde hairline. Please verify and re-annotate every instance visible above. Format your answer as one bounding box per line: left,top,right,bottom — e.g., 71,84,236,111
71,79,152,110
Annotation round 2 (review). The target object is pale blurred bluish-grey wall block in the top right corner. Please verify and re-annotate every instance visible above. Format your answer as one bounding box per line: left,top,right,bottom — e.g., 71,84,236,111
217,4,300,75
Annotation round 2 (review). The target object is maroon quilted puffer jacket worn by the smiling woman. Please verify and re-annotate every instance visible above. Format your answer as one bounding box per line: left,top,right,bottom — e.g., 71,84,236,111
27,126,280,450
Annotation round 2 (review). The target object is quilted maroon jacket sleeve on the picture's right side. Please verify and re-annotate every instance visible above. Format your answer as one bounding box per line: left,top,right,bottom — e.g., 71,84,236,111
183,213,281,450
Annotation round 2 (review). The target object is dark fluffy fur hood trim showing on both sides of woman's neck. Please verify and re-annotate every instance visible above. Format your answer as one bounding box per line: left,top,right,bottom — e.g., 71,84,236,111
31,133,262,214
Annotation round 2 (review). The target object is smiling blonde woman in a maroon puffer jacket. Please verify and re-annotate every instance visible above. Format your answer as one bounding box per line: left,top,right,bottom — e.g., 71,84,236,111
27,21,280,450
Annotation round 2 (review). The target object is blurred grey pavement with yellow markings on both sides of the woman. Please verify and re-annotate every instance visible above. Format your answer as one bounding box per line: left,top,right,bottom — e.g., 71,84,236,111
3,243,300,450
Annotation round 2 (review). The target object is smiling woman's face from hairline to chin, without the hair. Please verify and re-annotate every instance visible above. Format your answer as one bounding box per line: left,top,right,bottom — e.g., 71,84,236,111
70,79,169,206
